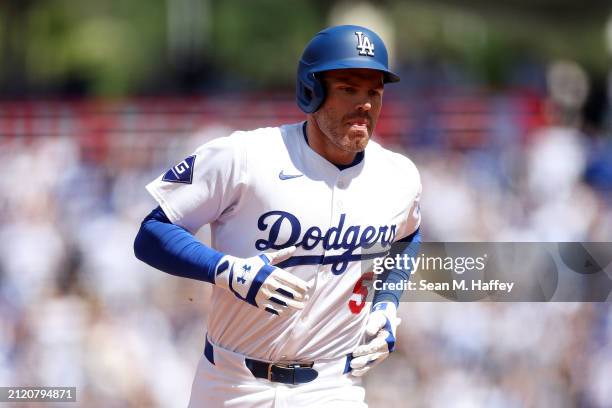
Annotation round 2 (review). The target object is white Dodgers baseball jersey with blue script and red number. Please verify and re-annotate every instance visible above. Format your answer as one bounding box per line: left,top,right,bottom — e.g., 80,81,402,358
147,123,421,361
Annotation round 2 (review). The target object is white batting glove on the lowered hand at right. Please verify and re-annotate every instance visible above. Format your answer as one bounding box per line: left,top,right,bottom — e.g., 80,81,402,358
351,302,401,377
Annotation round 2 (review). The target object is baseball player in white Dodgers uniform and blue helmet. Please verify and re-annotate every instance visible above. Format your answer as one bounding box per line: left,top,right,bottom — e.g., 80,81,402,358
134,25,421,407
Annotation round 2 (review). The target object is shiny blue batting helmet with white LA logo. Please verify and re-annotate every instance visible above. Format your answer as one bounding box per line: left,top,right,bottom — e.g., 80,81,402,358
296,25,399,113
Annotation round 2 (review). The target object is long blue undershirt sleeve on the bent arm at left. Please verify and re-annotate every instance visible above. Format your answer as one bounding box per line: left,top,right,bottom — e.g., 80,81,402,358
134,207,224,283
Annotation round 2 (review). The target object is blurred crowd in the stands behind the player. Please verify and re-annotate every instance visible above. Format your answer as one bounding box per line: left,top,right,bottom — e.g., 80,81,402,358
0,61,612,407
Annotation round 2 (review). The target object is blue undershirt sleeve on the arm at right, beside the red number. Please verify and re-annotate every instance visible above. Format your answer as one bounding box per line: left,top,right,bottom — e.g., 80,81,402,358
372,228,421,307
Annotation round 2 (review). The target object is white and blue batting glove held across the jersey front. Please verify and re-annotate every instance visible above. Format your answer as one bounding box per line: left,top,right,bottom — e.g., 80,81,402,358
215,246,310,315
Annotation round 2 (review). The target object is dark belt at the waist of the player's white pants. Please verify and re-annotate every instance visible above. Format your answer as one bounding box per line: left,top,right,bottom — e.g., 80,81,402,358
204,338,319,385
